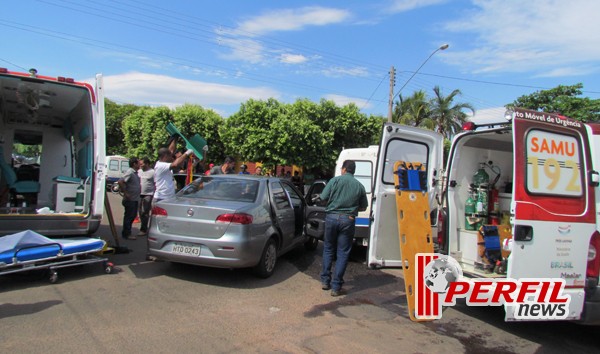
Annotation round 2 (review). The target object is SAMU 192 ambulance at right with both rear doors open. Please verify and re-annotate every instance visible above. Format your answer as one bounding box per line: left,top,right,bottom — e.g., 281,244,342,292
368,108,600,324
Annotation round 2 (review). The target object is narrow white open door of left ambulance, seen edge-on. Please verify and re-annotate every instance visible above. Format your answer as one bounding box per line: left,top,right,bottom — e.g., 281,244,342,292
90,74,107,220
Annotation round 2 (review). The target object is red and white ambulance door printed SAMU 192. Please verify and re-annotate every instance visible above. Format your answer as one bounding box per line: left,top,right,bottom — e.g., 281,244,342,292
506,109,596,321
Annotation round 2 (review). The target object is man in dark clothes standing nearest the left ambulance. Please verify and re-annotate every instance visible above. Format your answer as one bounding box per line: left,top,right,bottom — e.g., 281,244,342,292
117,157,141,240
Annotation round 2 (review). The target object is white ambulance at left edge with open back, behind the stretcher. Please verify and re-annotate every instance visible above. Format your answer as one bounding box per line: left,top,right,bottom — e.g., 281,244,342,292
0,68,106,236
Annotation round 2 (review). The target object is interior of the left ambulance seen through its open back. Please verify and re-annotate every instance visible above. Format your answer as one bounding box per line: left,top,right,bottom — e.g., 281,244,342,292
0,74,93,217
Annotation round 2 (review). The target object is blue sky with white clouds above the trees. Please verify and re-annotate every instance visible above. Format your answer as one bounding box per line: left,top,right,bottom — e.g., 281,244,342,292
0,0,600,120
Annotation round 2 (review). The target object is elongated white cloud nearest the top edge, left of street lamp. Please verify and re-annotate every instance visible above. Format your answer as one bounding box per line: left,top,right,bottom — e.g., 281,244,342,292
237,6,350,36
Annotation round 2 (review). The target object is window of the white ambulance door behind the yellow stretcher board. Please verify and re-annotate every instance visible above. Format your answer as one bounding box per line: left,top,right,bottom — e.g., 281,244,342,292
383,139,429,184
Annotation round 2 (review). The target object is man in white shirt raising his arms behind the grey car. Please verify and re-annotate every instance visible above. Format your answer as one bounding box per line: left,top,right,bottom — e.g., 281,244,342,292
152,138,193,206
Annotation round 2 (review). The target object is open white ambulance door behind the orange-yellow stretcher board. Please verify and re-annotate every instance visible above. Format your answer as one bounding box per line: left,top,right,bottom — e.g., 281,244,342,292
367,123,443,268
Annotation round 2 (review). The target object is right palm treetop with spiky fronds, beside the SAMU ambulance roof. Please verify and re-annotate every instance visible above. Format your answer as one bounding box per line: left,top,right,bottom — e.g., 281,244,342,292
430,86,475,139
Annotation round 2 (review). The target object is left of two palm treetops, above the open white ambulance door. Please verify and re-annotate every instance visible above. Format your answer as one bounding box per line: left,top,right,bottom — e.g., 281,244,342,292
393,90,433,129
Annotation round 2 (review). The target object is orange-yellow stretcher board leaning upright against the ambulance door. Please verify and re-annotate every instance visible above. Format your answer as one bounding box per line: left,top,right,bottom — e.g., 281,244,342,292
394,161,433,321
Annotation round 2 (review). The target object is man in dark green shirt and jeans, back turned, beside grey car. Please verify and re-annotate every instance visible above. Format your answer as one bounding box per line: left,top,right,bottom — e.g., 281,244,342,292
319,160,368,296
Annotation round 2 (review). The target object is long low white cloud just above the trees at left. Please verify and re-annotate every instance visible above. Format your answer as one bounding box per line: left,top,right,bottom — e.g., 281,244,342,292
104,72,280,108
